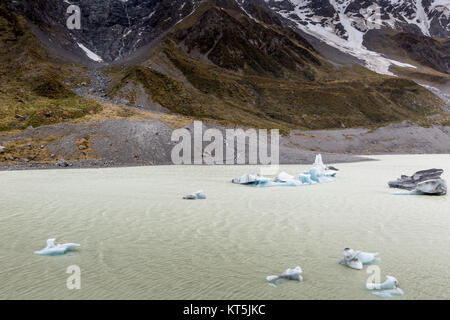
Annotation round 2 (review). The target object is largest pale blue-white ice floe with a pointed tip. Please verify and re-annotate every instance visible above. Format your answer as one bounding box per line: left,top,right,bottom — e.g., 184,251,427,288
232,154,338,187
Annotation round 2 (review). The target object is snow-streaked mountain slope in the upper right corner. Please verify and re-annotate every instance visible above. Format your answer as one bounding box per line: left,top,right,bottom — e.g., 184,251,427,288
251,0,450,74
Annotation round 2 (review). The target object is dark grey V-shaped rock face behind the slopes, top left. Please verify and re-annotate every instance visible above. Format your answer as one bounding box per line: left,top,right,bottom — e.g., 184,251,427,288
7,0,198,62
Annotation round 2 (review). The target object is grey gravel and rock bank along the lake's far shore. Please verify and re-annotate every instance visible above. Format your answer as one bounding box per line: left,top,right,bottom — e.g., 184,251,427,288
0,119,450,171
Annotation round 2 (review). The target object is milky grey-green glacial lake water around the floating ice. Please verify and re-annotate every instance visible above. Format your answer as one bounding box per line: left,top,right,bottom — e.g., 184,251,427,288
0,155,450,300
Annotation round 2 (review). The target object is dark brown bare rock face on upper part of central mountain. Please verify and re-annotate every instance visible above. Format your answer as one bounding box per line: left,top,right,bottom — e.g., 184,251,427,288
175,7,321,80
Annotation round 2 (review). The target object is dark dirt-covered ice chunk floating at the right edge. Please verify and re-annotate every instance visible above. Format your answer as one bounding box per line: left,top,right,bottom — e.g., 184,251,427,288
388,169,447,196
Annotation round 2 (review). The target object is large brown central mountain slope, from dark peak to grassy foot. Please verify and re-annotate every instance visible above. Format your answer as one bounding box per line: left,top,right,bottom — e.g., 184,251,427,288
104,1,442,130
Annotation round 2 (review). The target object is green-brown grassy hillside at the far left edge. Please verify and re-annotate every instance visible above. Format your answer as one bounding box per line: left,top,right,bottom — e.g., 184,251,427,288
0,6,100,131
